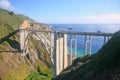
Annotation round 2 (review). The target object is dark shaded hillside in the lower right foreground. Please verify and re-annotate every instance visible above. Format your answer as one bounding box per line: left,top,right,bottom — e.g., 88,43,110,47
55,31,120,80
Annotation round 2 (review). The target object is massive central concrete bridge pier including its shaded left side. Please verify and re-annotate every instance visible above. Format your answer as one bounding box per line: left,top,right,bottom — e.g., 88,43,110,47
54,33,68,76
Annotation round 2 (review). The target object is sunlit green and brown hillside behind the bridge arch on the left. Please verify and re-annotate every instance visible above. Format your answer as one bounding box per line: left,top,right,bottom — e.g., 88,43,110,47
0,9,53,80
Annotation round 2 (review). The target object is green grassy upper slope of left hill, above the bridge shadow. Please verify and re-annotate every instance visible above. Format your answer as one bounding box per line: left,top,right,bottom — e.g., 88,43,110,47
0,9,23,29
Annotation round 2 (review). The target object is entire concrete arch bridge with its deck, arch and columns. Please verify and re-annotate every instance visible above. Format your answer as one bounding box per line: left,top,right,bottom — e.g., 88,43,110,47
20,28,113,76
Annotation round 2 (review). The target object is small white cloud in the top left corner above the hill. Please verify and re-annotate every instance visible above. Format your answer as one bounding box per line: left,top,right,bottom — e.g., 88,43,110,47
0,0,15,10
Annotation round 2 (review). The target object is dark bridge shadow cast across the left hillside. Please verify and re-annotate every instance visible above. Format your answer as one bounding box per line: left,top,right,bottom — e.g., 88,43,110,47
0,30,20,53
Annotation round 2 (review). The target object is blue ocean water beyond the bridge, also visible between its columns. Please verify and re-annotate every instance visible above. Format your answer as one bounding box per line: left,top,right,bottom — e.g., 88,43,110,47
50,24,120,56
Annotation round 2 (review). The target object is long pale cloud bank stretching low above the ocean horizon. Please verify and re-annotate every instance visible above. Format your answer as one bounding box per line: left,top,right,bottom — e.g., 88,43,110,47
57,14,120,24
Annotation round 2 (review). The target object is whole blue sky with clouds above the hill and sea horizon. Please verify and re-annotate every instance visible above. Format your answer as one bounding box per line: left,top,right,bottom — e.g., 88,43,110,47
0,0,120,23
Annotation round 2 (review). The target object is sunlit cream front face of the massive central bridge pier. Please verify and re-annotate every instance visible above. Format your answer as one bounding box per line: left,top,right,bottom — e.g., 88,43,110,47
57,34,67,72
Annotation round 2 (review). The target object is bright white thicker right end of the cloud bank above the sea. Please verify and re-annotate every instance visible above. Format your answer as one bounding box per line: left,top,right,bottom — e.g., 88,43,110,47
81,14,120,23
